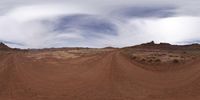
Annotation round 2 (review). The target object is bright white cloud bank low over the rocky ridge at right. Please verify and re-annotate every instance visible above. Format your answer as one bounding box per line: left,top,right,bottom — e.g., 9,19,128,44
94,16,200,47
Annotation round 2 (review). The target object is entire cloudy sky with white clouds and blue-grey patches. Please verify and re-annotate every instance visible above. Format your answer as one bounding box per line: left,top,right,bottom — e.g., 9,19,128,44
0,0,200,48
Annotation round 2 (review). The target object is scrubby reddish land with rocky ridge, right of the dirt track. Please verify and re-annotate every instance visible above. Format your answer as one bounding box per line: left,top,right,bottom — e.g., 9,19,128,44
123,41,200,71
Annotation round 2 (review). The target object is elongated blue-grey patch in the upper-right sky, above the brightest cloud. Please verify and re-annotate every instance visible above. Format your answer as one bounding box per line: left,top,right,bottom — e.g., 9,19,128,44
113,6,176,18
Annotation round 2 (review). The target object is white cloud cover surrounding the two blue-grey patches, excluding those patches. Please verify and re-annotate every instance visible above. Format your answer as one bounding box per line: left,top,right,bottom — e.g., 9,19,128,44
0,0,200,48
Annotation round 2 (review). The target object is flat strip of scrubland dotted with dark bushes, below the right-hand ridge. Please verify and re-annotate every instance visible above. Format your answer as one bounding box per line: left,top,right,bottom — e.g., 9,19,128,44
125,49,195,64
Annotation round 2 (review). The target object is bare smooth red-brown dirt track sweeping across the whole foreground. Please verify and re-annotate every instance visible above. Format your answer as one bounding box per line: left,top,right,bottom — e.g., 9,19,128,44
0,51,200,100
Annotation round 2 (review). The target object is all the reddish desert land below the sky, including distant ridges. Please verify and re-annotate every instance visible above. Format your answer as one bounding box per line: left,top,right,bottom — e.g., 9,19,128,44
0,42,200,100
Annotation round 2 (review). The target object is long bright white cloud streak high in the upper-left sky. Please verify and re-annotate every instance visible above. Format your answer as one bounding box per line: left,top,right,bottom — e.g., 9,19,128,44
5,4,92,21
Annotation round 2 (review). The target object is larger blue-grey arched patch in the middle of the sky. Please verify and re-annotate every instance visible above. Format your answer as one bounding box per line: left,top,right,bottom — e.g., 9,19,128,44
54,15,117,37
